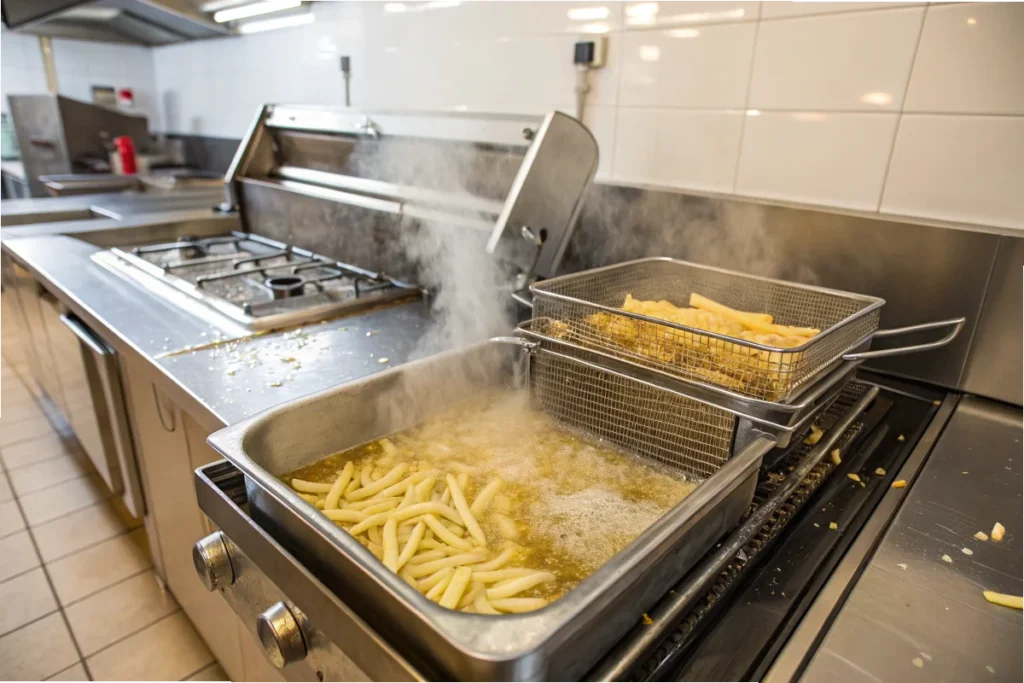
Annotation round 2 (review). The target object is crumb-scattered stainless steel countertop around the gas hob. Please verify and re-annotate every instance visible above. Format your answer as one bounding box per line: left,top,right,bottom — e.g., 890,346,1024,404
3,236,430,430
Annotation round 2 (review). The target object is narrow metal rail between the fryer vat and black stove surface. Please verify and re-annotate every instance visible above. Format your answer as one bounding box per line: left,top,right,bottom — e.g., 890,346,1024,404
588,387,879,682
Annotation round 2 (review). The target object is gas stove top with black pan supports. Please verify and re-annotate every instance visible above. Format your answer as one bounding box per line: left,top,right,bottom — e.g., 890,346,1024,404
93,232,422,331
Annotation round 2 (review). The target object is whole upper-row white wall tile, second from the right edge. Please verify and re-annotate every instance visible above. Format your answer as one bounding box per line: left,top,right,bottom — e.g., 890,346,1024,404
750,7,925,111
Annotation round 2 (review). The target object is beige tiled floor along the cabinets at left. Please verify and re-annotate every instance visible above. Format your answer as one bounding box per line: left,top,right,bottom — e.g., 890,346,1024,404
0,293,227,682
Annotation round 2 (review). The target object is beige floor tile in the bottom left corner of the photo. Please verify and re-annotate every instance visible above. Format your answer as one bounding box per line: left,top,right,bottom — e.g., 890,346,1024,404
0,614,78,681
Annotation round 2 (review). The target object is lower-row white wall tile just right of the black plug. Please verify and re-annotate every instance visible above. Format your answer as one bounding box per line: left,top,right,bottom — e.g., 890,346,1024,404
612,109,743,191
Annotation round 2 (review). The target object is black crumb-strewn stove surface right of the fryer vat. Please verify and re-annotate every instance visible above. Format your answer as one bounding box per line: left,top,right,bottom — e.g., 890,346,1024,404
598,373,945,682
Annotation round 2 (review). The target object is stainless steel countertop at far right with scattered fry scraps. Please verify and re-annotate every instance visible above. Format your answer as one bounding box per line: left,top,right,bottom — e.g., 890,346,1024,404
802,396,1024,683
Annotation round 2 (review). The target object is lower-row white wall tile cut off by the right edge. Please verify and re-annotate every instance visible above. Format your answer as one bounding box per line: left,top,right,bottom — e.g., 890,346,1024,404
882,114,1024,228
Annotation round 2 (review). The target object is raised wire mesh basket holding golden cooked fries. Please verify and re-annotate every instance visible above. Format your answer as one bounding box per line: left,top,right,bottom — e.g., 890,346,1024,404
530,258,885,402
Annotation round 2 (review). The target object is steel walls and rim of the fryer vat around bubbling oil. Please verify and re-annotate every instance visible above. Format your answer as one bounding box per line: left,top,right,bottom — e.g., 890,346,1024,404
197,339,773,680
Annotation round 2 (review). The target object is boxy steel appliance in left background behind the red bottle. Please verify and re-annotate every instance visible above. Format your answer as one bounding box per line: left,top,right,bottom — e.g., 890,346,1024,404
8,95,150,197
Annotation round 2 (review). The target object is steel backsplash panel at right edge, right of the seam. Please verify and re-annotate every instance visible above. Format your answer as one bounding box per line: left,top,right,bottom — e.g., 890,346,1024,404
963,238,1024,405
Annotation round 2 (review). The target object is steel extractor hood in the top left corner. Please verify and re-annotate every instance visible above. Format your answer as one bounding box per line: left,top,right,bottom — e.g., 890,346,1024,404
0,0,232,45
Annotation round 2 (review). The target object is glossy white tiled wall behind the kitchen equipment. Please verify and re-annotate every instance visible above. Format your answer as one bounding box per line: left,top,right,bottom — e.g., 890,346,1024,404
0,0,1024,228
